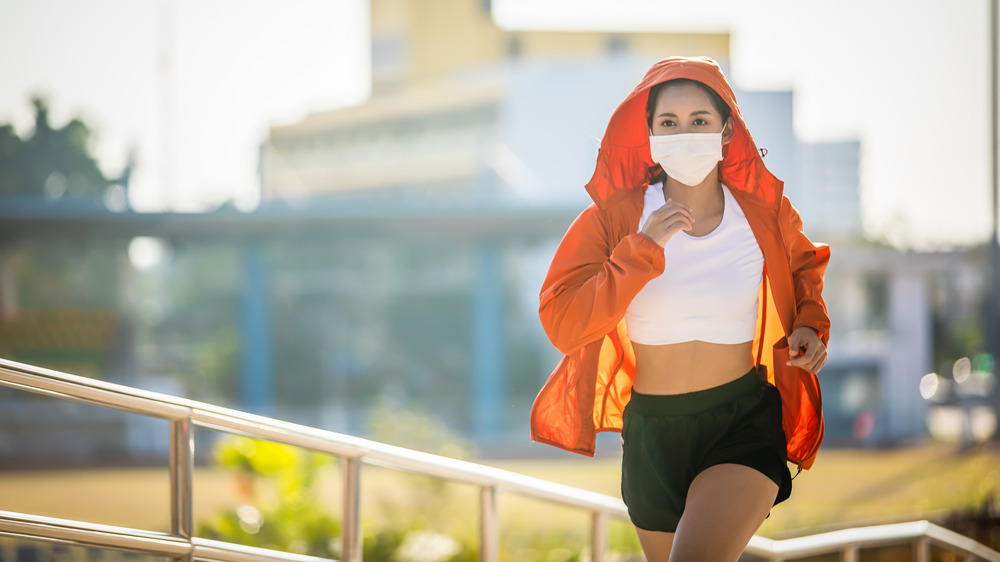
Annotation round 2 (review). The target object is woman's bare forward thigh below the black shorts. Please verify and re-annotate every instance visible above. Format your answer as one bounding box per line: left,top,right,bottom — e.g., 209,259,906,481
668,464,778,562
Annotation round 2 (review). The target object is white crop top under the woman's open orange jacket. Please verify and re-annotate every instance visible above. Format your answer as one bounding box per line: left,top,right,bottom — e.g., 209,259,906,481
625,183,764,345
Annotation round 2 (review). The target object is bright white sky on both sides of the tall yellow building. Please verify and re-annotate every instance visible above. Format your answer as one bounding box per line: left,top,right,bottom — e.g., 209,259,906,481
0,0,992,249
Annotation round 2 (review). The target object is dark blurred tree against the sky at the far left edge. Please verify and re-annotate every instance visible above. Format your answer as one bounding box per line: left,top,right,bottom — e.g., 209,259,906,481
0,98,112,200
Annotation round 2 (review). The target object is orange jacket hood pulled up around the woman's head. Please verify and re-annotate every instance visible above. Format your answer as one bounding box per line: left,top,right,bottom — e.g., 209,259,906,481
587,57,784,208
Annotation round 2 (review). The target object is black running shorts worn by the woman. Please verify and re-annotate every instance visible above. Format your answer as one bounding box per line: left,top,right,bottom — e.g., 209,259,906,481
622,369,792,533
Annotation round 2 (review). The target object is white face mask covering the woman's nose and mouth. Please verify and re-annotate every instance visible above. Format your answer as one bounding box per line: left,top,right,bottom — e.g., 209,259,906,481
649,123,726,185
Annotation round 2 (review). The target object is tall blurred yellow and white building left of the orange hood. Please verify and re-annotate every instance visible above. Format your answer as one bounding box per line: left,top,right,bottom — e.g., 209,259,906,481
262,0,729,203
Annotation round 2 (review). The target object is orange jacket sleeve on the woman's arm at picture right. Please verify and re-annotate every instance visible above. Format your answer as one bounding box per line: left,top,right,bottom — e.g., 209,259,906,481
778,197,830,345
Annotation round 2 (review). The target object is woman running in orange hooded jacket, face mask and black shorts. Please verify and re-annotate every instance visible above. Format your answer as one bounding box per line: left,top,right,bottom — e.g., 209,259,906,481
531,57,830,562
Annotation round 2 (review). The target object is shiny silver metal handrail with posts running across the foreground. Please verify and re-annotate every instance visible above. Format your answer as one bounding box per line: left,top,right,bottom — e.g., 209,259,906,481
0,359,1000,562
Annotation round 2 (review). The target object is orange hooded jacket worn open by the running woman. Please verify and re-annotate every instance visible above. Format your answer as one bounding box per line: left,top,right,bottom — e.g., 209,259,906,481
531,57,830,468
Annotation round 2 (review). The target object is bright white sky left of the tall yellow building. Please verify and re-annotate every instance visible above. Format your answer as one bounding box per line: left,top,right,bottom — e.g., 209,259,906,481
0,0,370,210
